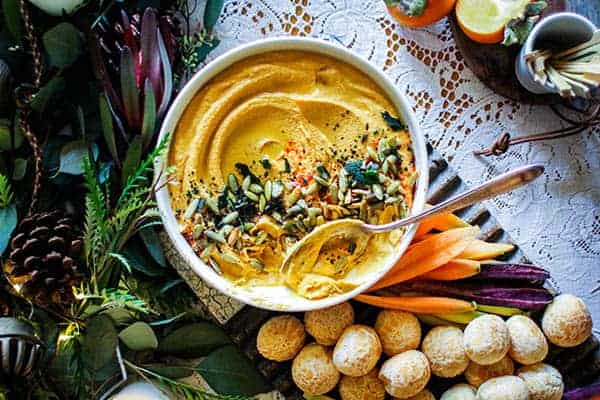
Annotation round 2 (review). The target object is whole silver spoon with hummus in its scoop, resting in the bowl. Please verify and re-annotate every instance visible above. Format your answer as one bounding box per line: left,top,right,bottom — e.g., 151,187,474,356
281,164,544,273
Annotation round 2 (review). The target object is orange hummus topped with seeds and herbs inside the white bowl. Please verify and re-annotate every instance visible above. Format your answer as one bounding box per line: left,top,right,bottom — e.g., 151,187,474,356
169,51,416,299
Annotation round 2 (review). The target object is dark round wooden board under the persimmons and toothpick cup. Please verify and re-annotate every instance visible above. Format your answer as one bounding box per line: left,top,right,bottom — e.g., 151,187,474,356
450,0,566,104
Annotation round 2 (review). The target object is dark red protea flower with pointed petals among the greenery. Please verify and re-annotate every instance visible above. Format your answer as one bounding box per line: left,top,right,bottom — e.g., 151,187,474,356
91,8,174,165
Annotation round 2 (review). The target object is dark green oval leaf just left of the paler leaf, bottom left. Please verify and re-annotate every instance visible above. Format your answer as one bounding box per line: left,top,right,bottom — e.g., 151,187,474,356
81,314,119,371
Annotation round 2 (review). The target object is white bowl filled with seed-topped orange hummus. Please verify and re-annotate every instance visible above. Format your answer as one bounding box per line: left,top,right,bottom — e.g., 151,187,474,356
156,38,428,311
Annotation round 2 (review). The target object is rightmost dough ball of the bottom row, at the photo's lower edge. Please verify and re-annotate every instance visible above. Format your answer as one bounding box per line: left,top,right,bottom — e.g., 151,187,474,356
517,363,565,400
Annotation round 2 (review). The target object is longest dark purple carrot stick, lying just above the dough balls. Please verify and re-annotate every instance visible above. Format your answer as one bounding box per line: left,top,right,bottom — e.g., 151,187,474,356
394,281,552,310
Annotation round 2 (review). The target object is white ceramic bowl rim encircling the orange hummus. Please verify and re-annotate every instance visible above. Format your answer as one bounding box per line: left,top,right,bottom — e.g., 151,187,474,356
155,37,429,311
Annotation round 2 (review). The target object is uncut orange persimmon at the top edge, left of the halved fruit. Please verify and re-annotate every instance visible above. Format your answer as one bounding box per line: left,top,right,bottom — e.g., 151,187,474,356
386,0,456,28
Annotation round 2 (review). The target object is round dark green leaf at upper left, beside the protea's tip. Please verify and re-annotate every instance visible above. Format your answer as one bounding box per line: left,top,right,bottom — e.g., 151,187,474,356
42,22,83,68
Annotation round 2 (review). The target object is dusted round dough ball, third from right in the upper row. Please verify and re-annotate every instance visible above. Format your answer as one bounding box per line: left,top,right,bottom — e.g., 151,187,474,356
463,314,510,365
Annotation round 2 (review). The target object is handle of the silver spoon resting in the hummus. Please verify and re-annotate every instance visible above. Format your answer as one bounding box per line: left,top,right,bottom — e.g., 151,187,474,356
365,164,544,232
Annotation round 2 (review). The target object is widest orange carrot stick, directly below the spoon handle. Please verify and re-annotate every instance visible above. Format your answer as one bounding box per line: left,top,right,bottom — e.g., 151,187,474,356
369,226,479,291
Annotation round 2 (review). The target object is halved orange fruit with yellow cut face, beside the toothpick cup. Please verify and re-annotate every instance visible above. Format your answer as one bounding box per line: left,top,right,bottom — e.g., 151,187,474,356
456,0,530,43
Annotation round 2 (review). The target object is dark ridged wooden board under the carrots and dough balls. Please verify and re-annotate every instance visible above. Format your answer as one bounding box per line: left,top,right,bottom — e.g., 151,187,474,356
224,146,600,399
